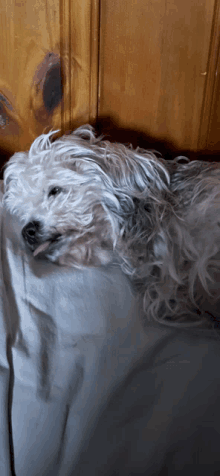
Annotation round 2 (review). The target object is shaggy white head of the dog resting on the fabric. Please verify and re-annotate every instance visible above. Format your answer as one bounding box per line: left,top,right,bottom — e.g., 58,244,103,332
4,126,169,267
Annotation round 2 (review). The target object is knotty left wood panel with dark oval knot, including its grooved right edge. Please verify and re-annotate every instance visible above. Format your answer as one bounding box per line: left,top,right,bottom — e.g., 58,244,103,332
0,0,99,153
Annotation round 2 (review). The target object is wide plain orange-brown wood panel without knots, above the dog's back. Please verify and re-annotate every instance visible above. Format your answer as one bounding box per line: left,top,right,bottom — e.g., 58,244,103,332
99,0,215,150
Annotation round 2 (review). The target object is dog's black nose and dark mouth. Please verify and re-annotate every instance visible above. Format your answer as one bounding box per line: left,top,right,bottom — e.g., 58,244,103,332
21,221,61,255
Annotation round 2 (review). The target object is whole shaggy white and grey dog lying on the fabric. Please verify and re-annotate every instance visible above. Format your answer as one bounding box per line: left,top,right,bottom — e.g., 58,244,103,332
4,126,220,330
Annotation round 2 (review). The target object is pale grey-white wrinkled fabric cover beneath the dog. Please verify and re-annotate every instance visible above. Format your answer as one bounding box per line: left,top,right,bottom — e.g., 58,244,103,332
0,183,220,476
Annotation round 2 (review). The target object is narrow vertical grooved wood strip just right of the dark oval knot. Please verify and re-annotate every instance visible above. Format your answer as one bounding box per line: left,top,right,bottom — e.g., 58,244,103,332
61,0,99,130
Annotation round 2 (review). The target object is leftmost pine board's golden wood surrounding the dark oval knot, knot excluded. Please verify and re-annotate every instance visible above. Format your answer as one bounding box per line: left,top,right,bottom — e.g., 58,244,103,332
0,0,60,151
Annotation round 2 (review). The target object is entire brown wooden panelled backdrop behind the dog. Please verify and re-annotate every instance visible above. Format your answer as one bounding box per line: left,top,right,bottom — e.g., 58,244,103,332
0,0,220,161
